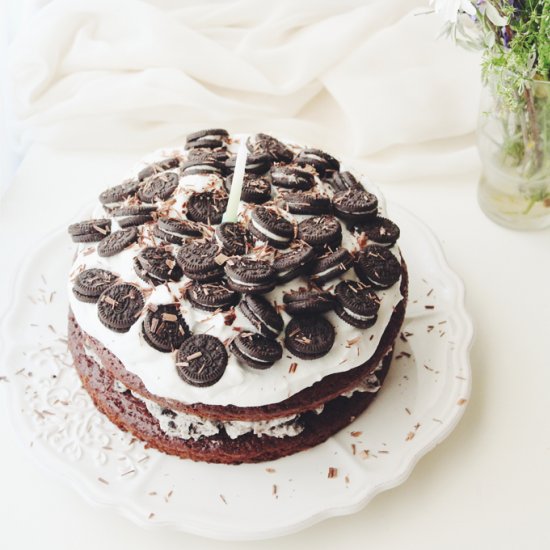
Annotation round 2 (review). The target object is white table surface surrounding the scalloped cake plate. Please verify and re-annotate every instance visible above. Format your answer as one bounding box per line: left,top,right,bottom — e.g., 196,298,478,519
0,140,550,550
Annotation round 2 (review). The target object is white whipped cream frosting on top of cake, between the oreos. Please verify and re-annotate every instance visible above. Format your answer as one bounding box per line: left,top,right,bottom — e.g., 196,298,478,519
68,135,403,407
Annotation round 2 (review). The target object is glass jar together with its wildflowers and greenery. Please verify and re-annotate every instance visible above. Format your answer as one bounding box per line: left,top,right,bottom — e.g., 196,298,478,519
432,0,550,229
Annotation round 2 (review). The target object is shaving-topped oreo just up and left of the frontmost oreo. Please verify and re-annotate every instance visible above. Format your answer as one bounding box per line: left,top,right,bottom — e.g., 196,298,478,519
141,304,191,353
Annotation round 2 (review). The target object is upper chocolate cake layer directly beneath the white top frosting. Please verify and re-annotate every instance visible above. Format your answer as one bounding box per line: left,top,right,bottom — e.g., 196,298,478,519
69,262,408,421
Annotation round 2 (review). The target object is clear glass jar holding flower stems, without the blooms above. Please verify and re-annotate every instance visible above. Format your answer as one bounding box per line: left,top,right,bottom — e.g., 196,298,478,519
477,74,550,230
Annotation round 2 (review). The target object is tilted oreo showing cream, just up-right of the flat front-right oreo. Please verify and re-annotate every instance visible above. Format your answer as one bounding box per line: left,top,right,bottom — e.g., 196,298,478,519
334,281,380,329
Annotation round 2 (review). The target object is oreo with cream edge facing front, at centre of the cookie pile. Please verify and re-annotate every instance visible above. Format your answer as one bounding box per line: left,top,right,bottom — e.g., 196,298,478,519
224,256,275,294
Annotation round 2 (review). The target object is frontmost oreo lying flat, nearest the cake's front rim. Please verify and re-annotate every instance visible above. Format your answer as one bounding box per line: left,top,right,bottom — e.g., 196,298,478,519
176,334,228,387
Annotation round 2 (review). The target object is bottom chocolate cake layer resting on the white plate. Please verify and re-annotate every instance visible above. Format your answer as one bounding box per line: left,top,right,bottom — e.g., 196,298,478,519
69,332,393,464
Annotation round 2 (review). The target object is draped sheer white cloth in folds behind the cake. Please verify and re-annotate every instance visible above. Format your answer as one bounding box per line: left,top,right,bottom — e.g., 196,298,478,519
7,0,479,180
